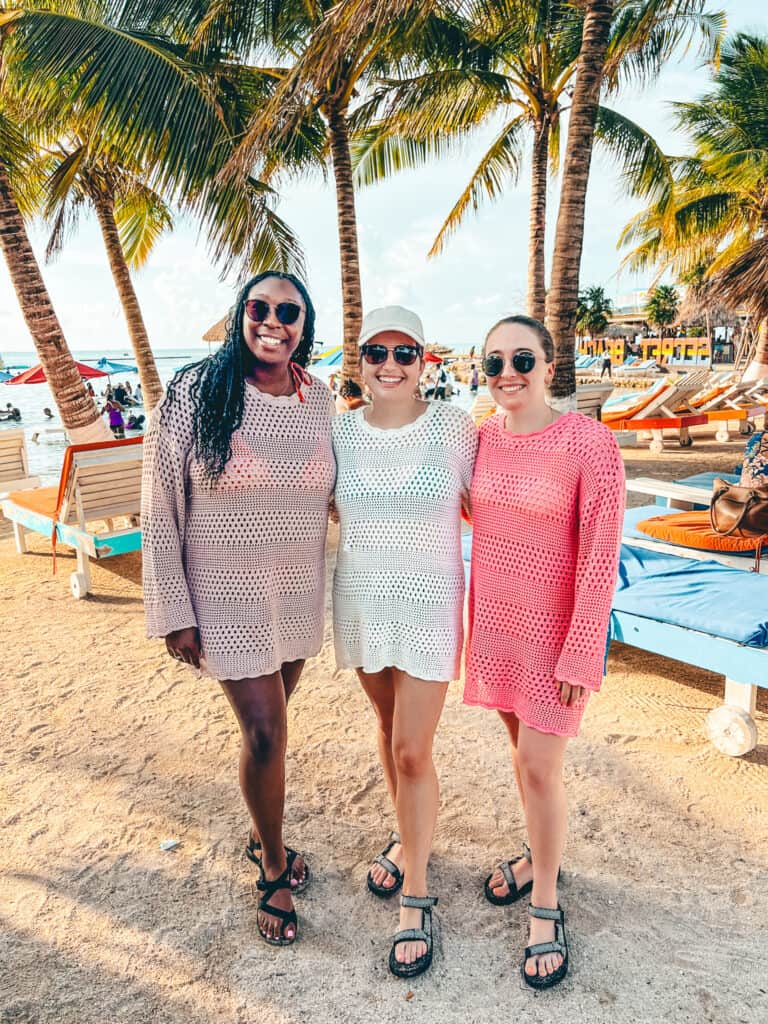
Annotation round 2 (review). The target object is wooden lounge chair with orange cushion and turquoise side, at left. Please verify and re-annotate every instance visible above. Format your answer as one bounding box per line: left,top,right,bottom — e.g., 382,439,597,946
2,437,143,599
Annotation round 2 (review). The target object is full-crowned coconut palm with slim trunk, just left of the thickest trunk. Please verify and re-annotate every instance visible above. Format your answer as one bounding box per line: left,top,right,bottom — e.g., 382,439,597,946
346,0,722,385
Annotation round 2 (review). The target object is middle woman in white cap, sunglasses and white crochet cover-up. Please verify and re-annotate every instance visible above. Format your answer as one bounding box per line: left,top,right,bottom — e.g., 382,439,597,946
333,306,477,977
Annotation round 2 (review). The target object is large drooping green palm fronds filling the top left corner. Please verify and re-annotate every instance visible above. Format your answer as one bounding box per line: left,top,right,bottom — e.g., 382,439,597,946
0,0,313,284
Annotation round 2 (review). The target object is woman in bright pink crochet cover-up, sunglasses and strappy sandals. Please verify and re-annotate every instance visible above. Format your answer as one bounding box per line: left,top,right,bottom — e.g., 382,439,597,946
464,316,625,988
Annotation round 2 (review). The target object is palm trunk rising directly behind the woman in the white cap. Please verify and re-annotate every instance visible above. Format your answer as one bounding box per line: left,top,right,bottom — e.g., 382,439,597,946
326,104,362,383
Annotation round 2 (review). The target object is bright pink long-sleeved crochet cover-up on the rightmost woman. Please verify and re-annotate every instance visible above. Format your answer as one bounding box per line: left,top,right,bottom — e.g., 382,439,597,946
464,413,625,736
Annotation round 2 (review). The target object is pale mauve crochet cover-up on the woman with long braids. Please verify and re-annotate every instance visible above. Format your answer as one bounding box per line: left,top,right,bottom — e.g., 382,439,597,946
141,378,335,679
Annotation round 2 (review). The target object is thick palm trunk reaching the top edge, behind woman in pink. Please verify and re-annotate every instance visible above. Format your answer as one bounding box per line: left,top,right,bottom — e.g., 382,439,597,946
547,0,613,408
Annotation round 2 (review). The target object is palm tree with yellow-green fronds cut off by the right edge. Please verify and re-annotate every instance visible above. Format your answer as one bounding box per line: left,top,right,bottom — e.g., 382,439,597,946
621,34,768,380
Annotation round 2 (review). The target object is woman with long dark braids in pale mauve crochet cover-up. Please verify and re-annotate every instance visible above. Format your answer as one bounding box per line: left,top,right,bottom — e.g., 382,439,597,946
141,271,335,945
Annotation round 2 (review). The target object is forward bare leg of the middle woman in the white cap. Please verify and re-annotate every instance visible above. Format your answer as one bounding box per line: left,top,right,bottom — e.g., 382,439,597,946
392,672,447,964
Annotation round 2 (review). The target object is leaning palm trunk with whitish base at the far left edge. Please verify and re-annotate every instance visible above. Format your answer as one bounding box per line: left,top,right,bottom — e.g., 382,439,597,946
0,161,112,444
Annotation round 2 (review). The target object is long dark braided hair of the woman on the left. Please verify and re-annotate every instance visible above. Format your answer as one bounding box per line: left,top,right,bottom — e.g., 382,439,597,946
161,270,314,486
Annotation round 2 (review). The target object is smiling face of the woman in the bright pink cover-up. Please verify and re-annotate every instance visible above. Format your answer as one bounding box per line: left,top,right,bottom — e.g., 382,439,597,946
483,324,555,413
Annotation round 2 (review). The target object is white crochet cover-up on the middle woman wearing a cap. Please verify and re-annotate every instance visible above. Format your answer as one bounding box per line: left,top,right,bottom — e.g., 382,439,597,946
333,401,477,681
